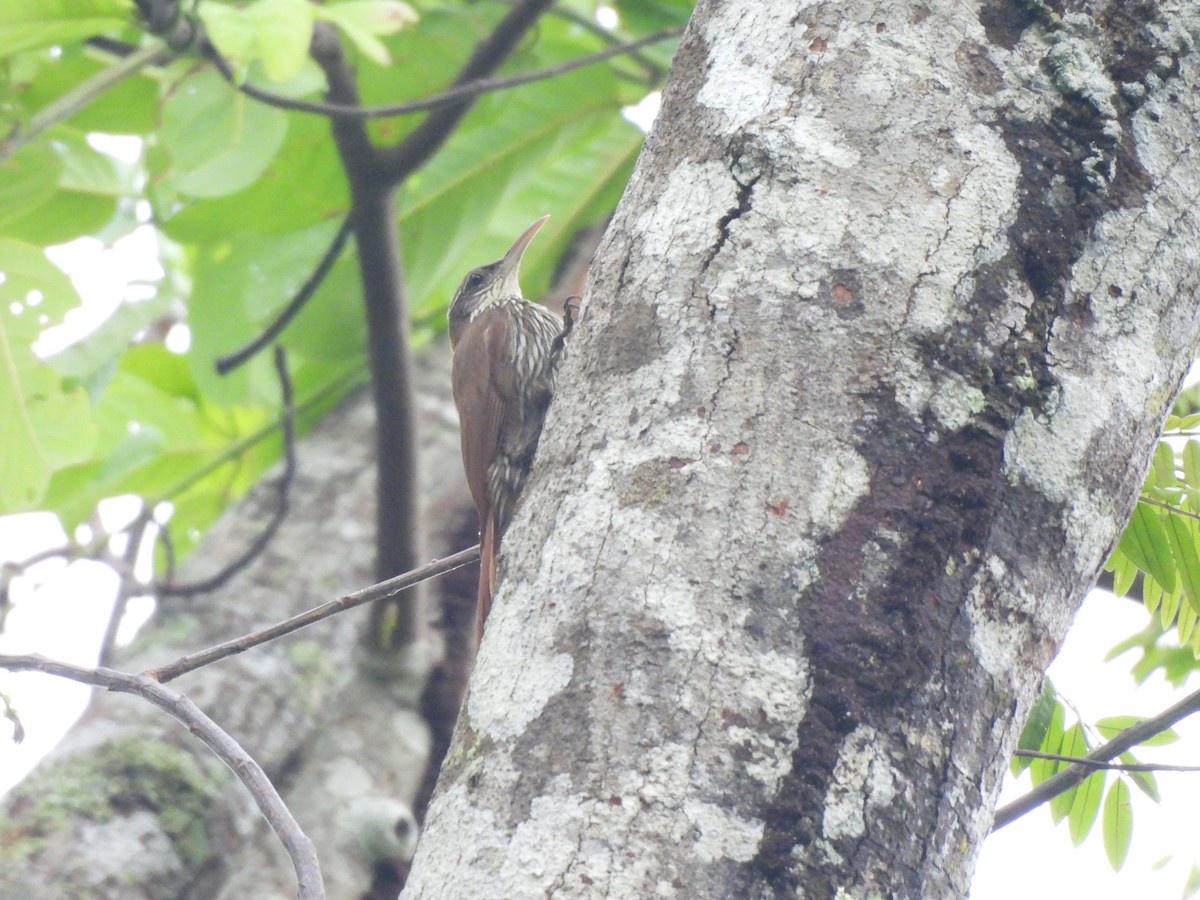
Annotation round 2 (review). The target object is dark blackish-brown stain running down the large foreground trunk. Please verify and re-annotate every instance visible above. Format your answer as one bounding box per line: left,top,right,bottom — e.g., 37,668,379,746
743,0,1183,898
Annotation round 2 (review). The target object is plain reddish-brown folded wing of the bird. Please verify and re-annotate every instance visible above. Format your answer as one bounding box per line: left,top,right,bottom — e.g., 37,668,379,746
451,310,512,524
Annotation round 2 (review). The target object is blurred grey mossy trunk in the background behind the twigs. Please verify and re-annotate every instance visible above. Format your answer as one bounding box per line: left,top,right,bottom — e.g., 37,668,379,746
0,348,474,900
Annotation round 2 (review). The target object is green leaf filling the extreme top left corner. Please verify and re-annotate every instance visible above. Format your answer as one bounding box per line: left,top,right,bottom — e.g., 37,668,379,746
0,0,133,56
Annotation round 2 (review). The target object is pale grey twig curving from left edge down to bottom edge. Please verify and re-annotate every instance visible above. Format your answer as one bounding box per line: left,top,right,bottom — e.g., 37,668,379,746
0,654,325,900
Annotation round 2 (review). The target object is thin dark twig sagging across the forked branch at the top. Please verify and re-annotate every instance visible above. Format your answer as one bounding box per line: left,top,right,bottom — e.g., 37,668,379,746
211,28,683,120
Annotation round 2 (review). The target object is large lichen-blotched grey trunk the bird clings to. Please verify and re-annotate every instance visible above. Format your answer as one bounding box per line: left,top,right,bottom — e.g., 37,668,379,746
406,0,1200,898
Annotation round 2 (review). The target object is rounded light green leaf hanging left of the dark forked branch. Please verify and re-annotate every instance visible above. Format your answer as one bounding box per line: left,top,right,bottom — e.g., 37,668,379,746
161,70,288,197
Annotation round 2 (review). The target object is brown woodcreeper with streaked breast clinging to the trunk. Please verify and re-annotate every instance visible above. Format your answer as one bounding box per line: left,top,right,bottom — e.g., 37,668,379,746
449,216,564,646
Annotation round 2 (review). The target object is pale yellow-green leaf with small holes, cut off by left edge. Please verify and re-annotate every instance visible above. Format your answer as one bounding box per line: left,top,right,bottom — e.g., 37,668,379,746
0,239,96,512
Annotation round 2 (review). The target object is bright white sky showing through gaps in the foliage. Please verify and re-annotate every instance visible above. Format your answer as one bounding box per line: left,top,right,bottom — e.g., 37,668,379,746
0,68,1200,900
